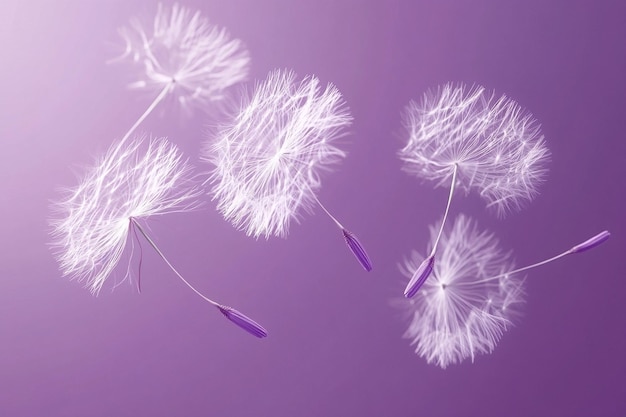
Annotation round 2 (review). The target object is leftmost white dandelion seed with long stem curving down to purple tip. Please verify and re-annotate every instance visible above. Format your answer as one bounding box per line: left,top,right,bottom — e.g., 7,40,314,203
50,138,266,337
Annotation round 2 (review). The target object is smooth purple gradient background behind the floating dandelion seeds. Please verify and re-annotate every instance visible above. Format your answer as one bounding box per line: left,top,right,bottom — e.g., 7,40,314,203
0,0,626,417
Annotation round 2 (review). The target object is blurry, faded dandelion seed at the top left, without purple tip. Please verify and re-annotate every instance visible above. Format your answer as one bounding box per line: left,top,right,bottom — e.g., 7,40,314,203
112,4,250,140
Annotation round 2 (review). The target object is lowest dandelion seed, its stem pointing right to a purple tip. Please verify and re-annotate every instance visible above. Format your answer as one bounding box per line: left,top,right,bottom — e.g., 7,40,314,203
401,215,610,368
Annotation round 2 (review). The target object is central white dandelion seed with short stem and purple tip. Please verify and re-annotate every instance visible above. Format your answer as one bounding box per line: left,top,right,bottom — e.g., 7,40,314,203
203,71,372,271
